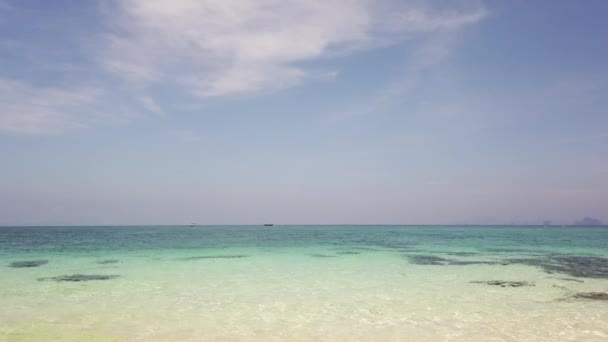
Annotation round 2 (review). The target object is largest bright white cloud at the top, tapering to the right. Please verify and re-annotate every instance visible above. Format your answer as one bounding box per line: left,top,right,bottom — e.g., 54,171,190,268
102,0,485,97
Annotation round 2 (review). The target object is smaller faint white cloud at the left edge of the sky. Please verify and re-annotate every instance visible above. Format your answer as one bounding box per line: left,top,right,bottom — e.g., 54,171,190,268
0,78,102,134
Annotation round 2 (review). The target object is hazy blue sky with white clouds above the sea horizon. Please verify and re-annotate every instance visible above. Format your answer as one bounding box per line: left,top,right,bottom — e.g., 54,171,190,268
0,0,608,225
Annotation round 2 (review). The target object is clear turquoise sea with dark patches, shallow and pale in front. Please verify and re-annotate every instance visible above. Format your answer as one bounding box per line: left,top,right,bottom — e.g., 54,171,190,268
0,226,608,341
